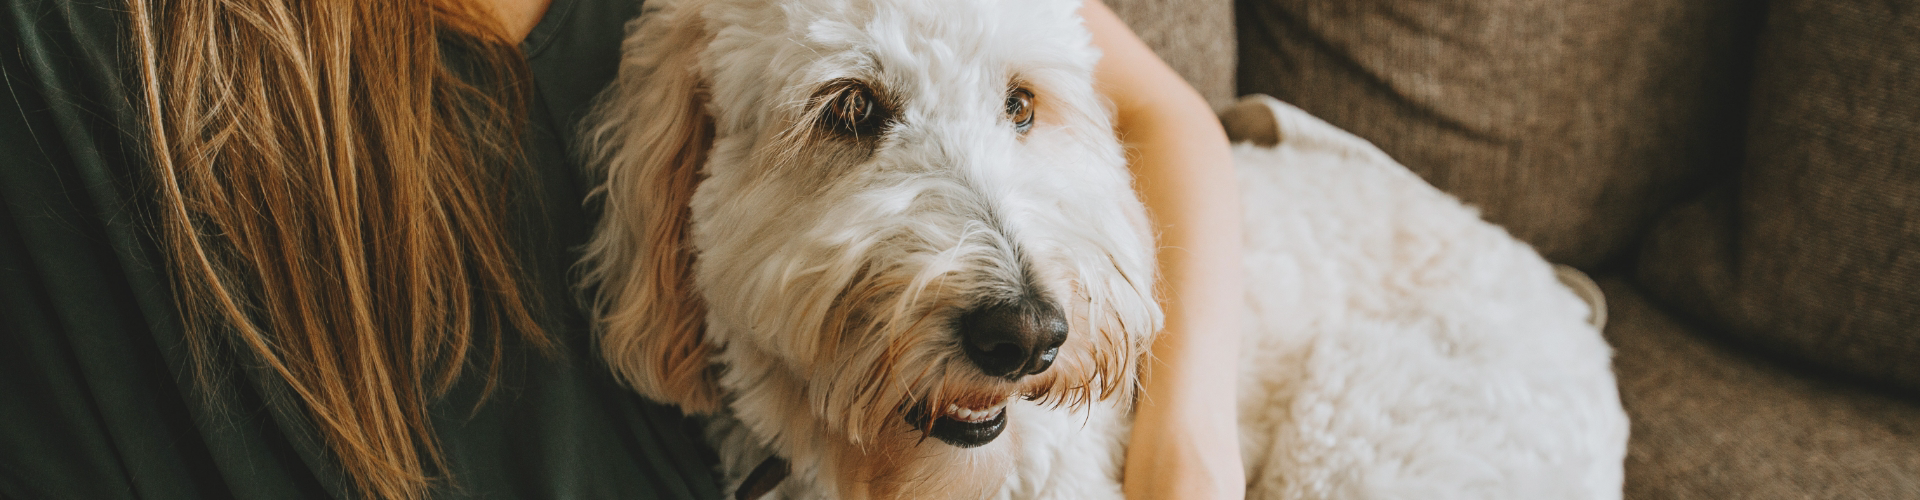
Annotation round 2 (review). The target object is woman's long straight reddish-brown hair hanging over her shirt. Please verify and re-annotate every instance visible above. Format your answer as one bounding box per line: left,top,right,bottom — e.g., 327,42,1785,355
127,0,545,498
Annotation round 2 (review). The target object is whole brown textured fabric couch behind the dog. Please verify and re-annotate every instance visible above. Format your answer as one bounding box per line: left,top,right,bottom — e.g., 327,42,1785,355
1108,0,1920,498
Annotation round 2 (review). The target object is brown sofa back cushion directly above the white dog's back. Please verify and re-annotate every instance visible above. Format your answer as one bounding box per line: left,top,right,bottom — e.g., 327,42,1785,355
1236,0,1759,269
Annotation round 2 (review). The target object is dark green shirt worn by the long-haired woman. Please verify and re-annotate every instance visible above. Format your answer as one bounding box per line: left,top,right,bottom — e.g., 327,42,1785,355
0,0,718,500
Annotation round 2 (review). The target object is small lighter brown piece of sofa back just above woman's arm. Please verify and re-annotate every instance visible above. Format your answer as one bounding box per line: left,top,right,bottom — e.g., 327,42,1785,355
1106,0,1235,110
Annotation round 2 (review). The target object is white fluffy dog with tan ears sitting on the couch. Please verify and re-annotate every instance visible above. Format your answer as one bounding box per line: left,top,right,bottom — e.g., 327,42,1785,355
584,0,1626,498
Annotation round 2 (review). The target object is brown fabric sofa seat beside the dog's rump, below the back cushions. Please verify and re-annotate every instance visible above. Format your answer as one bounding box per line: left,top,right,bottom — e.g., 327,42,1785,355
1601,279,1920,500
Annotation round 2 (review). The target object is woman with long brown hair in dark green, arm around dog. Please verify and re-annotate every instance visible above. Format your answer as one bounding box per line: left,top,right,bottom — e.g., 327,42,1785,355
0,0,1240,498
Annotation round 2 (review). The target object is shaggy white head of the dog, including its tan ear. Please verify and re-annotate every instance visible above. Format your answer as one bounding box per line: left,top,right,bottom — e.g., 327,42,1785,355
586,0,1160,496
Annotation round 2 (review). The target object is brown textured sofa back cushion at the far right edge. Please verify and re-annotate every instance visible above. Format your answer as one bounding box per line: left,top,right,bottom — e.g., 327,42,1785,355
1640,0,1920,394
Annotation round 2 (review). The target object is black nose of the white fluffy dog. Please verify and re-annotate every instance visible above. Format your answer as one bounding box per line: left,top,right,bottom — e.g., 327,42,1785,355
958,300,1068,379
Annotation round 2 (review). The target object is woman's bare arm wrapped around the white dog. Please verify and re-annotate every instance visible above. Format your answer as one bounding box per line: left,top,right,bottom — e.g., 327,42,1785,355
1081,0,1246,500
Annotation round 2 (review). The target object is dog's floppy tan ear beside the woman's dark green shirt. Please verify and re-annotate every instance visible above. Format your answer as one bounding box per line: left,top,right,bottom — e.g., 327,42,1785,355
582,2,720,413
